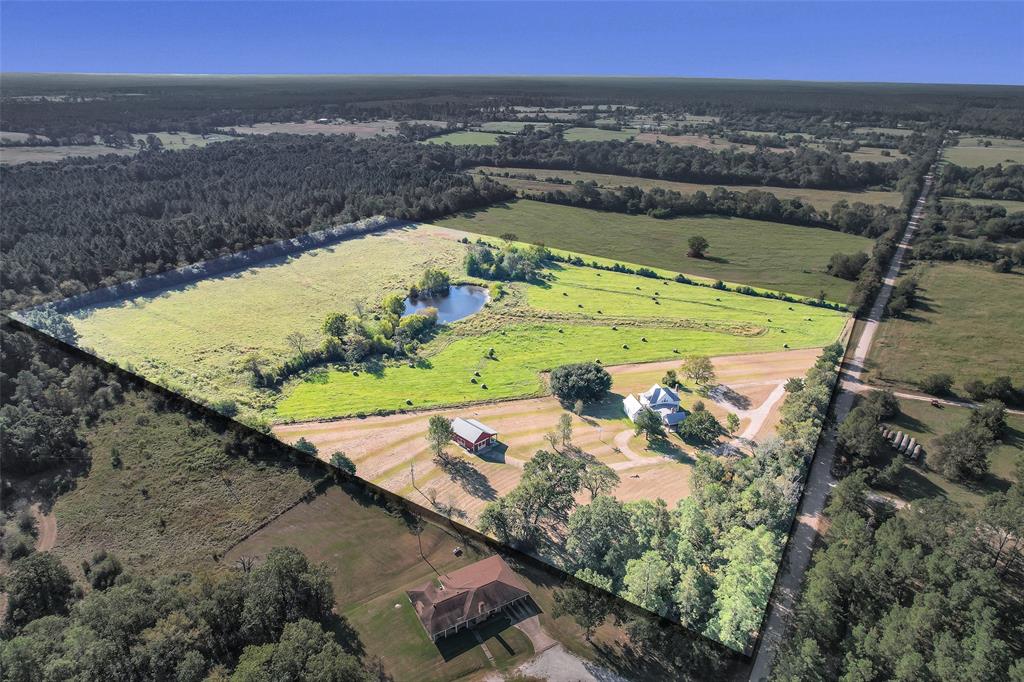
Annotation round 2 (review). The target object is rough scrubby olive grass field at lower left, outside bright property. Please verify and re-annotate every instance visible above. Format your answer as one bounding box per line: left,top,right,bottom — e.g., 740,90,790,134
54,393,323,572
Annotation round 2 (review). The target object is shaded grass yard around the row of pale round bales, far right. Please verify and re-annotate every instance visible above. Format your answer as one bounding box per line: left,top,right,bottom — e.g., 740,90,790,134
881,400,1024,506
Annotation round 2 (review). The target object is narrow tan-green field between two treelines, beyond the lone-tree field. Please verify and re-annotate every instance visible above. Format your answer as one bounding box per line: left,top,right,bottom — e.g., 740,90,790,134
474,166,903,211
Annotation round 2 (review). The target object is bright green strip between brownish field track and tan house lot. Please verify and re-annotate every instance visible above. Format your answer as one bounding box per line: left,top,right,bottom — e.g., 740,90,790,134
276,313,842,421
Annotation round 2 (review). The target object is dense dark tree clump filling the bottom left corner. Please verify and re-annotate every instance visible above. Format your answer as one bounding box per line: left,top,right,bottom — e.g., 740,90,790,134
0,547,379,682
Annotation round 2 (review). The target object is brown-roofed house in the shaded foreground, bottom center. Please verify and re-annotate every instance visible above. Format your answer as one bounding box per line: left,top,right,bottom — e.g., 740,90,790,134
406,554,529,642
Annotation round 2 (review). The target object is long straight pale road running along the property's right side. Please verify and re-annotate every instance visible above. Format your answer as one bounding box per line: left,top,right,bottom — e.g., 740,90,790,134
750,168,935,682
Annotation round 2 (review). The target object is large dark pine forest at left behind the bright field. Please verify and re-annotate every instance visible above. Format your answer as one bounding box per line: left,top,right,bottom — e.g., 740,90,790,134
0,135,514,307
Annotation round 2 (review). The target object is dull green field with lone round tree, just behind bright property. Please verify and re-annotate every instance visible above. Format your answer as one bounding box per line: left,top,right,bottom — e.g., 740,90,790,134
437,200,872,302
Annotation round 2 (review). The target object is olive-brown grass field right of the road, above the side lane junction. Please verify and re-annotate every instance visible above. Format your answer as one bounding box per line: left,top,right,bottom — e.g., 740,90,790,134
868,263,1024,387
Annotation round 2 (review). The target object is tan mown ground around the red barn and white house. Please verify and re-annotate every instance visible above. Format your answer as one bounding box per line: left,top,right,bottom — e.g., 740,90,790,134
274,348,818,524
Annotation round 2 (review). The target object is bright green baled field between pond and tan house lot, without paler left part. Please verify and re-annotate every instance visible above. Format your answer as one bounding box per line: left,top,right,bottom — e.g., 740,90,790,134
276,260,846,421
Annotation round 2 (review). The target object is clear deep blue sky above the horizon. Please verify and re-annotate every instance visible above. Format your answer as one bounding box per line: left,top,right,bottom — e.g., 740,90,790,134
0,0,1024,84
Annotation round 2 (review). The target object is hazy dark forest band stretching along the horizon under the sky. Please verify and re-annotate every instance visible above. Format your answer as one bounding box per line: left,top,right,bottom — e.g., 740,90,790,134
8,74,1024,143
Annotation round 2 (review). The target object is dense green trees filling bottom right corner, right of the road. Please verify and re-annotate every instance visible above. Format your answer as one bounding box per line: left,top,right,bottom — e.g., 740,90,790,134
772,466,1024,682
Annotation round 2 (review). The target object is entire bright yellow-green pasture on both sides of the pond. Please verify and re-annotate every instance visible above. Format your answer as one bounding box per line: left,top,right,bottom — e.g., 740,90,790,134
66,223,845,421
